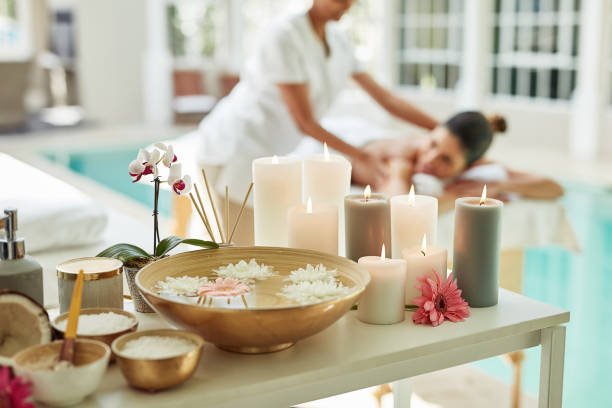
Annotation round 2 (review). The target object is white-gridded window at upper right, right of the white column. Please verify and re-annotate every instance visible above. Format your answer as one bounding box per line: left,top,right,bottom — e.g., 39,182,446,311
492,0,580,100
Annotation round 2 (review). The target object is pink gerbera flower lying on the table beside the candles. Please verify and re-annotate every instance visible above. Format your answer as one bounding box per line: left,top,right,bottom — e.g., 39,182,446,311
412,271,470,326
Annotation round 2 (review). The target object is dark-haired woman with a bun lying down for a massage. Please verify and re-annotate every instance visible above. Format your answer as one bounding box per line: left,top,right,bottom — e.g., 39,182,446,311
353,112,563,212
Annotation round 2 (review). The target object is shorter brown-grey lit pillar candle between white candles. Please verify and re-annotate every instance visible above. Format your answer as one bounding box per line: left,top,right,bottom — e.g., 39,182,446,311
344,188,391,262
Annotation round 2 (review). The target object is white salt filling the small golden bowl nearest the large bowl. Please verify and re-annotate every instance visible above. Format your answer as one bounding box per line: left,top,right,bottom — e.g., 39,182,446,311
121,336,197,360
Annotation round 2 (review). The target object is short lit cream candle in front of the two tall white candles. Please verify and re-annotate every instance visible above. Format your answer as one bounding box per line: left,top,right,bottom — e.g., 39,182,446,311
287,197,338,255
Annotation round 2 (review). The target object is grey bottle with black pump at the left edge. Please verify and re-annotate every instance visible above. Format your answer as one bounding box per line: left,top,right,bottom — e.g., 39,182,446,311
0,208,44,305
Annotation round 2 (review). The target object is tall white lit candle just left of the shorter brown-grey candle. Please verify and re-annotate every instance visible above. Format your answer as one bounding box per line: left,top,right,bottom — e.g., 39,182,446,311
303,144,351,255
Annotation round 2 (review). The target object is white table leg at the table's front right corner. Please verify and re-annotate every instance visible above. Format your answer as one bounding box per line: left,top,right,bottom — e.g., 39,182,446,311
538,326,565,408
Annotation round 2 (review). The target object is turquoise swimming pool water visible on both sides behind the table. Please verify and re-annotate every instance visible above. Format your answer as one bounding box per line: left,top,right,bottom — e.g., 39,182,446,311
44,146,612,407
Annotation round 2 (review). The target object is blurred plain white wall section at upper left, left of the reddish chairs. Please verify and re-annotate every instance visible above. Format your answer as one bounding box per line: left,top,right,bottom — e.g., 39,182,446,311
76,0,146,124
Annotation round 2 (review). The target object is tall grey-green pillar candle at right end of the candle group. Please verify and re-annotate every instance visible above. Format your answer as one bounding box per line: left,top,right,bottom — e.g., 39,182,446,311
453,193,503,307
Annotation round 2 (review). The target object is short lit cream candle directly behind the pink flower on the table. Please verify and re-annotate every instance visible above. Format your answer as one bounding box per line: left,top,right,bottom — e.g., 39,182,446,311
402,235,448,305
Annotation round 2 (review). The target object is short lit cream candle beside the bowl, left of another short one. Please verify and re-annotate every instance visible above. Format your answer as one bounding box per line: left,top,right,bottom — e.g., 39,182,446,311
357,245,406,324
